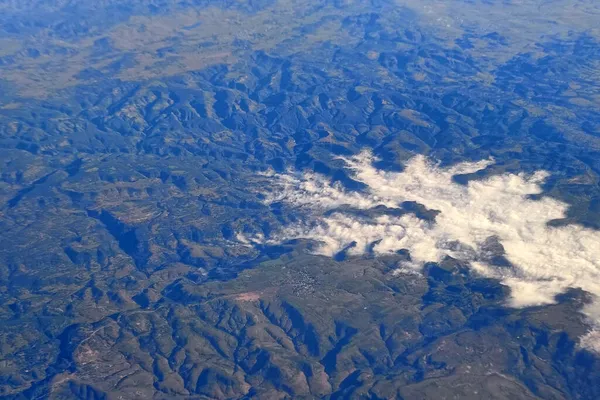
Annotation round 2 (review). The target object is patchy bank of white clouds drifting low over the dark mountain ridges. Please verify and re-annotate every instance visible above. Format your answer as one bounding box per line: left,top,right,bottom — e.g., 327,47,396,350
260,153,600,347
